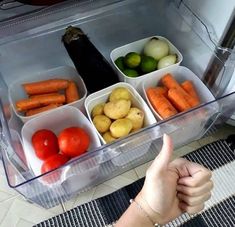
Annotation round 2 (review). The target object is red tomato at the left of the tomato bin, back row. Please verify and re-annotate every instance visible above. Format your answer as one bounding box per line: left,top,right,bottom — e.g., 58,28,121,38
32,129,59,160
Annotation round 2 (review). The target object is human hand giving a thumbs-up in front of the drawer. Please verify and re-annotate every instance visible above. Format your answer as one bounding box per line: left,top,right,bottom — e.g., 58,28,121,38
135,135,213,224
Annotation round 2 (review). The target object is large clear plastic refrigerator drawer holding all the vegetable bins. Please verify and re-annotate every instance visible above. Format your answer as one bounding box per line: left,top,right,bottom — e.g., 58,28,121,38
0,0,235,208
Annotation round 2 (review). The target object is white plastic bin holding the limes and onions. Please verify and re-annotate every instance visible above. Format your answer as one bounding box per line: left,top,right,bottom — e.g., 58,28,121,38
110,36,183,91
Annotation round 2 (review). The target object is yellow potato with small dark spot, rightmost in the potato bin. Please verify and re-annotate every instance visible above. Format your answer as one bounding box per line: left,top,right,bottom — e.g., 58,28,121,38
126,107,144,131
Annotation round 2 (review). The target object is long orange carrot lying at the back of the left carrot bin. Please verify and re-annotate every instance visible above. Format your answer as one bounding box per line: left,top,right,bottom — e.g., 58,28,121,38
22,79,68,95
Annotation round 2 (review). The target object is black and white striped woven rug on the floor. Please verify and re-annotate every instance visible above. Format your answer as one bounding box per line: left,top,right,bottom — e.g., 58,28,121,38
35,140,235,227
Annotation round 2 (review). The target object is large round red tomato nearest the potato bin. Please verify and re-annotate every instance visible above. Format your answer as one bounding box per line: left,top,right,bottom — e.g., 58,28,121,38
58,127,90,157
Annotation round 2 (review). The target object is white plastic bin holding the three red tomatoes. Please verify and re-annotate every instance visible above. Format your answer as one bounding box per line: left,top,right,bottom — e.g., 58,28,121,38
21,106,101,179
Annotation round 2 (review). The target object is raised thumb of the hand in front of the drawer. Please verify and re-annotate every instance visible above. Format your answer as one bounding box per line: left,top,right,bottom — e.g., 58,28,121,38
151,134,173,170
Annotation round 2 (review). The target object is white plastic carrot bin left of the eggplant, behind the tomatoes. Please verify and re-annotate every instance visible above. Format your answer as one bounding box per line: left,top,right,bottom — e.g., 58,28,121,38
9,66,87,122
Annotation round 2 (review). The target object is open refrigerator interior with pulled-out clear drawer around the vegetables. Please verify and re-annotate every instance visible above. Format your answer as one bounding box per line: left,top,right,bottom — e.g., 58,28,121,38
0,0,235,208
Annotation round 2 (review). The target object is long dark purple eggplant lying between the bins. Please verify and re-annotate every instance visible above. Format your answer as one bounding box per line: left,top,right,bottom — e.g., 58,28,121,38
62,26,119,93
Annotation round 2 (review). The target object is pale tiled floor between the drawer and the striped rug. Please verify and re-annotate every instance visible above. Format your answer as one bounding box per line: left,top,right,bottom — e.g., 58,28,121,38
0,125,235,227
